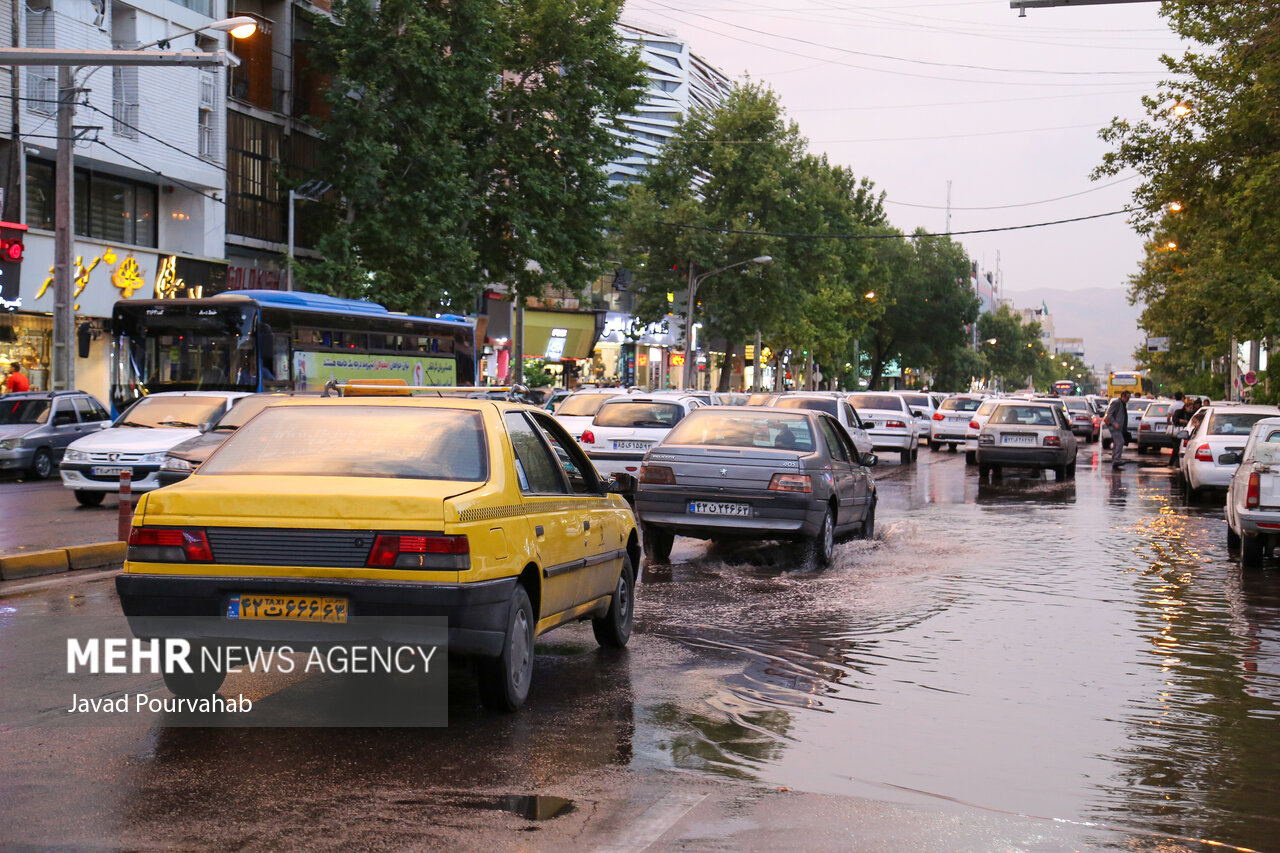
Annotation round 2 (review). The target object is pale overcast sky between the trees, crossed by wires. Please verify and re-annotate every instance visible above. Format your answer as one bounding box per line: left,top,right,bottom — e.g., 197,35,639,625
623,0,1180,301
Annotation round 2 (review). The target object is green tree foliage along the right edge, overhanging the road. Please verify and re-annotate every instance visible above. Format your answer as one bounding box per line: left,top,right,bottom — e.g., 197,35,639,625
1097,0,1280,383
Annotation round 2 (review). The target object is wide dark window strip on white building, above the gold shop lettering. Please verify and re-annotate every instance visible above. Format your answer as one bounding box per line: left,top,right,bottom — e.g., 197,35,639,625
27,160,157,247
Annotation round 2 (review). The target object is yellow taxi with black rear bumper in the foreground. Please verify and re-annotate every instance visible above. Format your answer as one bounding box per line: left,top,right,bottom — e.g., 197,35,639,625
116,396,640,711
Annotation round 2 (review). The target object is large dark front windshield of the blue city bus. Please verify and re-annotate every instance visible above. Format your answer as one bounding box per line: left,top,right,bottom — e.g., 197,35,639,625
111,304,259,409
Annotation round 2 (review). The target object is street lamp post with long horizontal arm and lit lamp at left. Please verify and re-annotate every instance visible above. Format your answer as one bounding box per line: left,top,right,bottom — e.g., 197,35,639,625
0,15,257,391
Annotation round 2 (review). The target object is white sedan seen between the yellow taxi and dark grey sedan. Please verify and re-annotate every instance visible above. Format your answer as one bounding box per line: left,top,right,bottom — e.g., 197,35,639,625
579,394,703,480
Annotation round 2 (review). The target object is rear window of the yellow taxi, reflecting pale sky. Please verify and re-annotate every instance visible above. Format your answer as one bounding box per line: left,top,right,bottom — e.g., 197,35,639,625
198,405,488,482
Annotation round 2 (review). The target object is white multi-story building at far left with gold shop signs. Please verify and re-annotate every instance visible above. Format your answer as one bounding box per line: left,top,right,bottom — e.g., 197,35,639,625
0,0,227,397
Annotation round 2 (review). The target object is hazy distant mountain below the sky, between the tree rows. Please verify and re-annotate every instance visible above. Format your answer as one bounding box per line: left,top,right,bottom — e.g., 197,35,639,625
1001,287,1146,370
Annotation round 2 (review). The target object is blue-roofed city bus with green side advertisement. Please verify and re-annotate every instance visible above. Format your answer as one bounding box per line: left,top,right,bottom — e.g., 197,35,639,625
110,291,476,412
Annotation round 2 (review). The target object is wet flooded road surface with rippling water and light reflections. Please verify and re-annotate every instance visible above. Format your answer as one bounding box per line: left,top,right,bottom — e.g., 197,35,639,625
0,446,1280,852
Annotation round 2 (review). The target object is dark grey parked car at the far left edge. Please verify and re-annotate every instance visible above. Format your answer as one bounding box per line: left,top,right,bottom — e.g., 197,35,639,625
0,391,111,480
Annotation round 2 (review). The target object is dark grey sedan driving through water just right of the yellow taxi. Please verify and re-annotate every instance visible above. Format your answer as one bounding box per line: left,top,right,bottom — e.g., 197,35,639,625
636,406,876,565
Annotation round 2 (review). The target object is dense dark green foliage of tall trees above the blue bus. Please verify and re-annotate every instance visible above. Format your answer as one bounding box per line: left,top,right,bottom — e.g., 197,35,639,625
300,0,643,311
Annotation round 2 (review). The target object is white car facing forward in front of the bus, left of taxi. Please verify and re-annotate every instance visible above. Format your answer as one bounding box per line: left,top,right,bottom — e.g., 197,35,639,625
59,391,246,506
